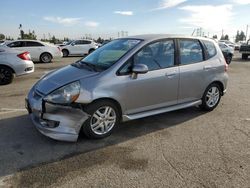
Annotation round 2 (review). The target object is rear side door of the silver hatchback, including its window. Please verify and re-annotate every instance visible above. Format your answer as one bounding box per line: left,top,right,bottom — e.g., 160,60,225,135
178,39,211,103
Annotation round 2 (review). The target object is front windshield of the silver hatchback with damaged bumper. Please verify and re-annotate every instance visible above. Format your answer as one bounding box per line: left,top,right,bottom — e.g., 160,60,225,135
76,39,141,71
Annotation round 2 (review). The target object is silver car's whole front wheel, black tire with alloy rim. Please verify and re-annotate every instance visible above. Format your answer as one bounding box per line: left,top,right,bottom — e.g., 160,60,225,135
82,100,120,139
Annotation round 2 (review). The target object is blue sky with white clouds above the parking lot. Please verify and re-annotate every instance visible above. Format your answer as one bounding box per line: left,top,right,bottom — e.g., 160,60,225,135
0,0,250,39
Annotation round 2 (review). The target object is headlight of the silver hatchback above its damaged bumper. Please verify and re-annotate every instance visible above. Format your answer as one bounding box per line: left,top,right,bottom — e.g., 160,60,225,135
44,81,80,104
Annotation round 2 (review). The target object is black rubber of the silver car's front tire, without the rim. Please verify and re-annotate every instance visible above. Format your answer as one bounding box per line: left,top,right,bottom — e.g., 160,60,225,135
82,100,121,139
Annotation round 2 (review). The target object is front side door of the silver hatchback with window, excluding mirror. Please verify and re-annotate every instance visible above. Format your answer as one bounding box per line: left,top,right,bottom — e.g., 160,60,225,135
119,40,179,114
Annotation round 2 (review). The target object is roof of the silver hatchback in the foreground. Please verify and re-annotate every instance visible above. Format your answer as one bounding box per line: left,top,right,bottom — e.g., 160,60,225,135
124,34,212,41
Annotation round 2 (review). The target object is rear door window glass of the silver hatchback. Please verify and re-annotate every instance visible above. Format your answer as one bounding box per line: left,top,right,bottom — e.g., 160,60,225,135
180,39,203,65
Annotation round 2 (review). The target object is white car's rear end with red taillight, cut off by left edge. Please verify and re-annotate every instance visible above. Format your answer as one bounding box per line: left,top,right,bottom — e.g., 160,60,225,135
0,46,34,85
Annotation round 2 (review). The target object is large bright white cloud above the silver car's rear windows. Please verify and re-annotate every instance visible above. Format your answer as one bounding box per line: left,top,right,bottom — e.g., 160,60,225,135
179,4,234,31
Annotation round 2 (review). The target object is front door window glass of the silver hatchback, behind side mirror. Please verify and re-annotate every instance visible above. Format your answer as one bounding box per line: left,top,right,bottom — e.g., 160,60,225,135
134,40,174,70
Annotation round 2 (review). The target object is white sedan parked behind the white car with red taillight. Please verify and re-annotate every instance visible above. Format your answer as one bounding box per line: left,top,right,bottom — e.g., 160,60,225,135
5,40,62,63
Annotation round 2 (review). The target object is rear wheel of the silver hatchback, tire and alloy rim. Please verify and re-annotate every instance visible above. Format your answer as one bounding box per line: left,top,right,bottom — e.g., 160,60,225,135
200,83,222,111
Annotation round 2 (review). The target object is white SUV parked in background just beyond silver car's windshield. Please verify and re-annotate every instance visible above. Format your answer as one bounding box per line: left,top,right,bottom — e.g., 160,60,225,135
61,39,98,57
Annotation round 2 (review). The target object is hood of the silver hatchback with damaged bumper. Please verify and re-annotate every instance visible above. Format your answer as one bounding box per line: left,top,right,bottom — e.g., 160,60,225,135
35,65,98,95
